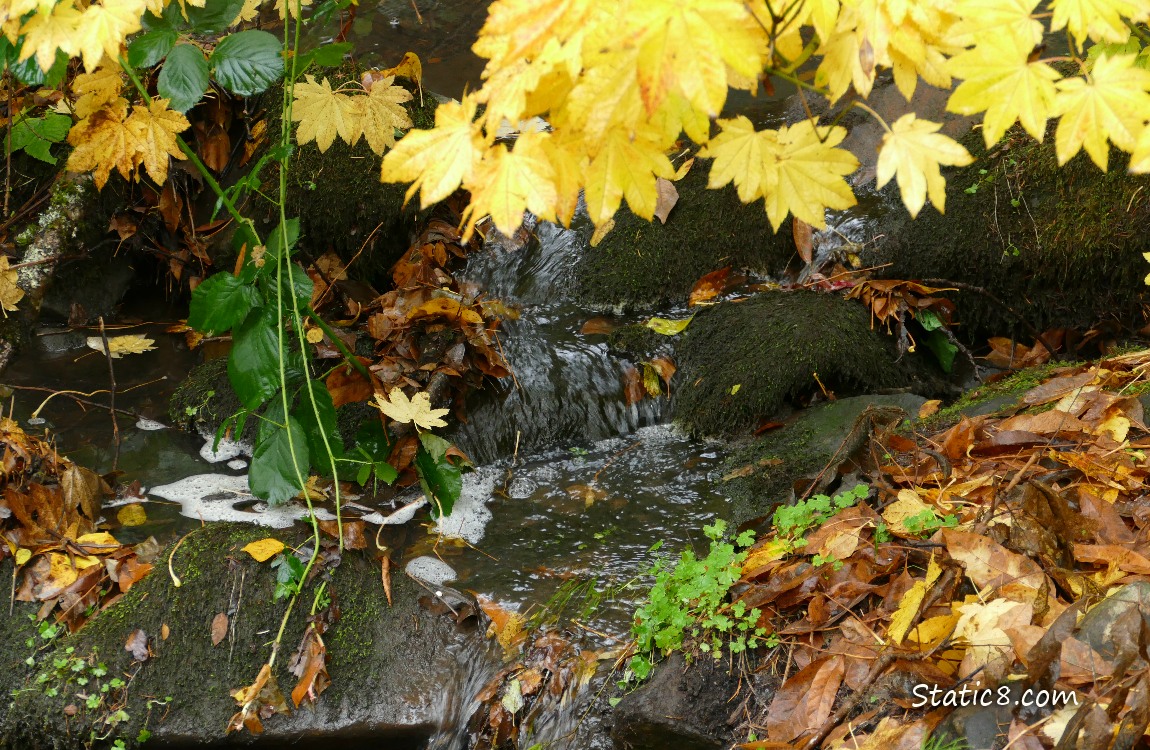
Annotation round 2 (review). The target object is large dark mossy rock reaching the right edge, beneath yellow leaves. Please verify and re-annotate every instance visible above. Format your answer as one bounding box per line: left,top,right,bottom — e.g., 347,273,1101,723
864,131,1150,342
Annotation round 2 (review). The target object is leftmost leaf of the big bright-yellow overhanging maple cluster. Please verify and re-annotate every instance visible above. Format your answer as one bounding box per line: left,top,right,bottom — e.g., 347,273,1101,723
381,97,482,208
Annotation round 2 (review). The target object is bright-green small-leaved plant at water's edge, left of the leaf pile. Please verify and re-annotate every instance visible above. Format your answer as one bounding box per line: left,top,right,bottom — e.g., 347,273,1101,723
622,520,771,684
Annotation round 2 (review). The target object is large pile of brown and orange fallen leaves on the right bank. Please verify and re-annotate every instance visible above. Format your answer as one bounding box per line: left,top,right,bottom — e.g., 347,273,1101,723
733,350,1150,750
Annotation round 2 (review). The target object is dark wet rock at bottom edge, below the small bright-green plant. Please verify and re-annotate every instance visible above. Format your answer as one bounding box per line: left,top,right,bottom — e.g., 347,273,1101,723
611,652,738,750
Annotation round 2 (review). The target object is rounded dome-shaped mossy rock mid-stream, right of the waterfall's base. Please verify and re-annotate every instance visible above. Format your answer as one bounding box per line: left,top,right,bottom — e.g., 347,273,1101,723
675,291,911,435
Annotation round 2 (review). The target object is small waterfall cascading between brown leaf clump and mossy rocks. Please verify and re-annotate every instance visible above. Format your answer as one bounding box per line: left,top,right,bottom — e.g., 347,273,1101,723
457,222,664,464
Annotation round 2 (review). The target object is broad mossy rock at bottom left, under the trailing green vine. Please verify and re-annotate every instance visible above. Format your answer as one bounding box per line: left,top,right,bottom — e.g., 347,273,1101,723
0,525,483,750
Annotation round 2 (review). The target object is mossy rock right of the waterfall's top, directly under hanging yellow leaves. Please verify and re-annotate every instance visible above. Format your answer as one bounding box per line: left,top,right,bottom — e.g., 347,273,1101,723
574,160,795,309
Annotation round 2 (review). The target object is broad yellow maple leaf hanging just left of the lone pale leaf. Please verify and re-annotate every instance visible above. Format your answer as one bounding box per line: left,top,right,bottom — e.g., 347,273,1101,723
762,120,859,231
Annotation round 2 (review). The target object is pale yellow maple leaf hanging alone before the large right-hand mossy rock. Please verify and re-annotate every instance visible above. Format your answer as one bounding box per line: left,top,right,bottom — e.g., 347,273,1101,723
876,112,973,217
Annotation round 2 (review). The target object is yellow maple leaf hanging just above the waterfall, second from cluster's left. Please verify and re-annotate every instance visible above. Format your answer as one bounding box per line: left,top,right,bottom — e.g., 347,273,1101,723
468,131,557,236
